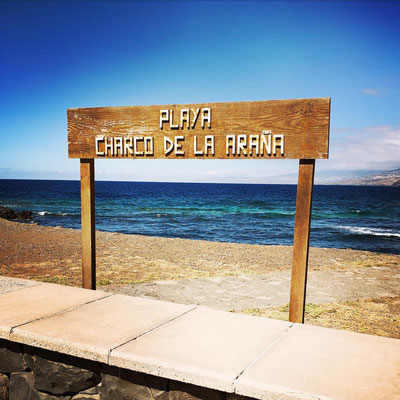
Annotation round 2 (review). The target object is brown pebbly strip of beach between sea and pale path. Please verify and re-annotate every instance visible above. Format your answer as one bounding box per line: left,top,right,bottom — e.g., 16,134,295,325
0,219,400,286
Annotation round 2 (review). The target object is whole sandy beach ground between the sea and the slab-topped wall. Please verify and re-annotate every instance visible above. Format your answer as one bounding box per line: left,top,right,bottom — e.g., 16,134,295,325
0,219,400,337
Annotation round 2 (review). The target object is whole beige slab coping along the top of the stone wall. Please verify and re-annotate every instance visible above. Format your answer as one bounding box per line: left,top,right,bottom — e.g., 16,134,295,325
0,278,400,400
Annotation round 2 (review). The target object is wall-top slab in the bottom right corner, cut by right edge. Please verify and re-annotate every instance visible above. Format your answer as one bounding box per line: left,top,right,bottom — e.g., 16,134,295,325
235,324,400,400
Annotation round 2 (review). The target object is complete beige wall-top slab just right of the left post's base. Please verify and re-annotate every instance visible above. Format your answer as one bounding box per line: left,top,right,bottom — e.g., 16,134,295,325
11,295,195,363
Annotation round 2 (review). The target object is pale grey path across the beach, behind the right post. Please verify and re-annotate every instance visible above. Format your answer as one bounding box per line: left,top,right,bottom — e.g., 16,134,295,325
102,266,400,311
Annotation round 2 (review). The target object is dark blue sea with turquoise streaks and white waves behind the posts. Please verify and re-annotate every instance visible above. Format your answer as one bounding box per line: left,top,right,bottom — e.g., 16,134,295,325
0,180,400,254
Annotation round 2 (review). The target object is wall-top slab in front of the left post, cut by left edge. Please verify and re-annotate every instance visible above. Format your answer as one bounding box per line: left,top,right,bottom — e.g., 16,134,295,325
0,283,110,339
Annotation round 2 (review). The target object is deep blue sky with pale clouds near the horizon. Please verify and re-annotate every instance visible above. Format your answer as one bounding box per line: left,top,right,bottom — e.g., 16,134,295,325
0,0,400,183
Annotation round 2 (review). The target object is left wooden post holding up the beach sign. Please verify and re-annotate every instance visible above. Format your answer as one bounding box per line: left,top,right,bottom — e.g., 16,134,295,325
81,158,96,290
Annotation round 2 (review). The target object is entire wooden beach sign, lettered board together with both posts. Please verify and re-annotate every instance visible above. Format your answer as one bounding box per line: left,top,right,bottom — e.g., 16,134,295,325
68,98,330,323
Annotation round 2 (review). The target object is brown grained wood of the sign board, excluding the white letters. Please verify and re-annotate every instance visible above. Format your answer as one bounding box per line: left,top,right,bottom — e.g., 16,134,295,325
67,98,330,159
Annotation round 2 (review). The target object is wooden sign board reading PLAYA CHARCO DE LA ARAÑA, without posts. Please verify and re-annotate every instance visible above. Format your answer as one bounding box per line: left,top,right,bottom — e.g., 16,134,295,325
68,98,330,160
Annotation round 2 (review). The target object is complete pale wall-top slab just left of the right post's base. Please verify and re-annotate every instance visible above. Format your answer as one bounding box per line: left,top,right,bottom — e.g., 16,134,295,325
109,307,292,393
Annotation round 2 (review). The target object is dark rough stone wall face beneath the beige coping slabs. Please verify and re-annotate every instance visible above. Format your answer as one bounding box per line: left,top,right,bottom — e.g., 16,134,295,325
0,339,250,400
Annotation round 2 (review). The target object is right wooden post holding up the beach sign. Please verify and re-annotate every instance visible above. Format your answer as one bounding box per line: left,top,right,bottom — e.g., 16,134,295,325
289,159,315,323
